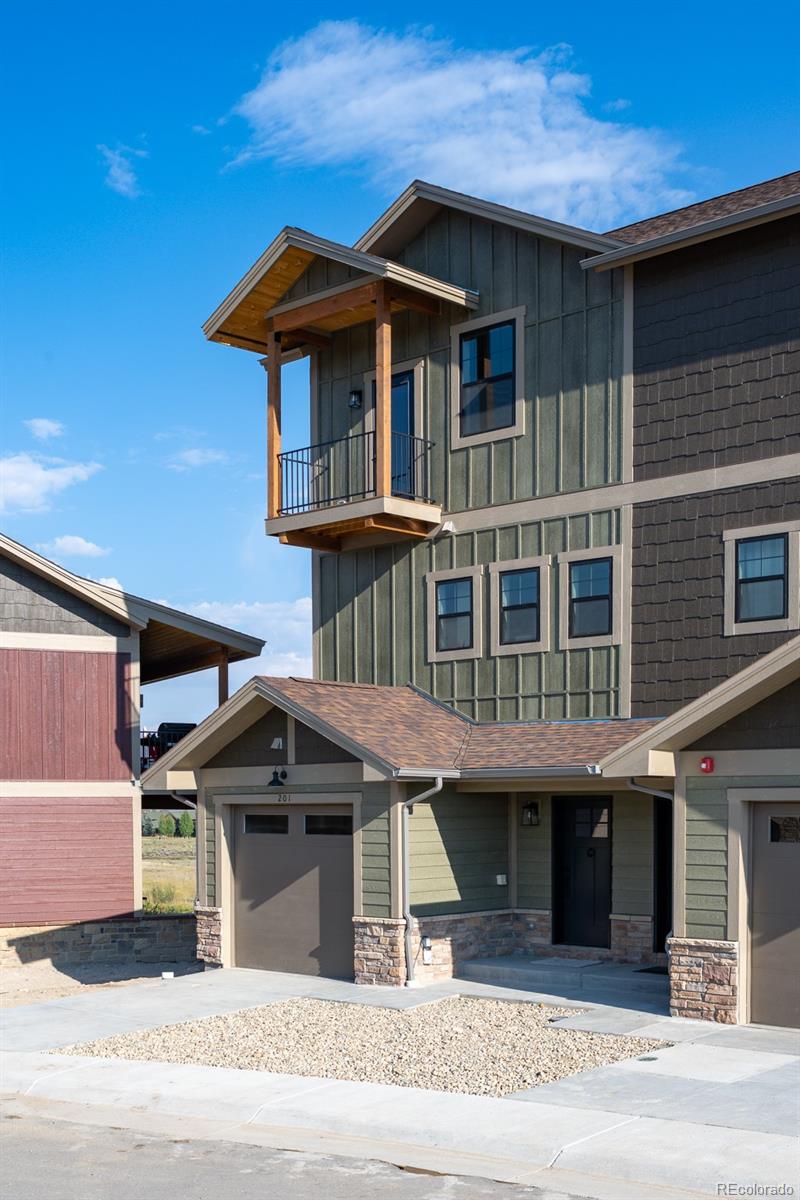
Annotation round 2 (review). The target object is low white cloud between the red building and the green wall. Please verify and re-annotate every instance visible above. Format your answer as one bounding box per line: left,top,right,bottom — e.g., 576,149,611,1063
143,596,312,728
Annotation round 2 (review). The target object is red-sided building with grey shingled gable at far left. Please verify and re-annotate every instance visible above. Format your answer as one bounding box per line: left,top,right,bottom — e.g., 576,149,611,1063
0,535,264,926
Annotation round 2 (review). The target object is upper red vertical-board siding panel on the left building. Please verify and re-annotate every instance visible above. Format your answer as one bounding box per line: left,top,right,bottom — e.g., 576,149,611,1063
0,649,133,781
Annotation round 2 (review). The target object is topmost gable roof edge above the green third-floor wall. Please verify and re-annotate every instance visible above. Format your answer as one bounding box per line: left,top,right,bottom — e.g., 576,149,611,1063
355,179,621,257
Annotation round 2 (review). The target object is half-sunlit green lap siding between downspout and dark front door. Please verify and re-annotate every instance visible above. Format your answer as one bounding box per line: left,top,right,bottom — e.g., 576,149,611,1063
409,791,509,917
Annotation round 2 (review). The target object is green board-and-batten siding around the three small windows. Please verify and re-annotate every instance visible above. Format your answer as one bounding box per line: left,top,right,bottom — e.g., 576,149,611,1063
317,509,621,721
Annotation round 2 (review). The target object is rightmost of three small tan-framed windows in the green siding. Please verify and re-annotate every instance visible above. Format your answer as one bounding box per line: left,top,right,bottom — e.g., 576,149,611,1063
558,546,630,650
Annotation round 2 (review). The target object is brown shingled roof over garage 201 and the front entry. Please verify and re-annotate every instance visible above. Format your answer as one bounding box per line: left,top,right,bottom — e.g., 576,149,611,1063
143,676,655,788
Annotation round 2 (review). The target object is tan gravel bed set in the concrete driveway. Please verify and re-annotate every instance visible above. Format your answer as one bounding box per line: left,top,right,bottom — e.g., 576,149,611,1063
64,996,669,1096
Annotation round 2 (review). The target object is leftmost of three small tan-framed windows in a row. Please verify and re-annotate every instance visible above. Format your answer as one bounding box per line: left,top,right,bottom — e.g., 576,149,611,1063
425,566,483,662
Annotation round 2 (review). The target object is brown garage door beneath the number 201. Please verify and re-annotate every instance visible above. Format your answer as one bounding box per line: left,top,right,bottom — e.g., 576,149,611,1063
234,804,353,979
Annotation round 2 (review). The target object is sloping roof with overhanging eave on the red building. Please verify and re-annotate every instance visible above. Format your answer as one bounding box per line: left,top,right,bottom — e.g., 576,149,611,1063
0,534,264,683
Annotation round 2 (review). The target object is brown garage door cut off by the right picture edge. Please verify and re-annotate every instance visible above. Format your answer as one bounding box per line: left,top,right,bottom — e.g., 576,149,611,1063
750,803,800,1027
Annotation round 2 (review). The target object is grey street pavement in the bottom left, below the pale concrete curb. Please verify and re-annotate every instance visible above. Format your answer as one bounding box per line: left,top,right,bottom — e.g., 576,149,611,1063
0,1115,578,1200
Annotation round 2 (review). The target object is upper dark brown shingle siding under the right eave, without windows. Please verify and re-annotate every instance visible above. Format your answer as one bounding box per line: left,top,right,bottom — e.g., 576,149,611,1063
633,217,800,479
